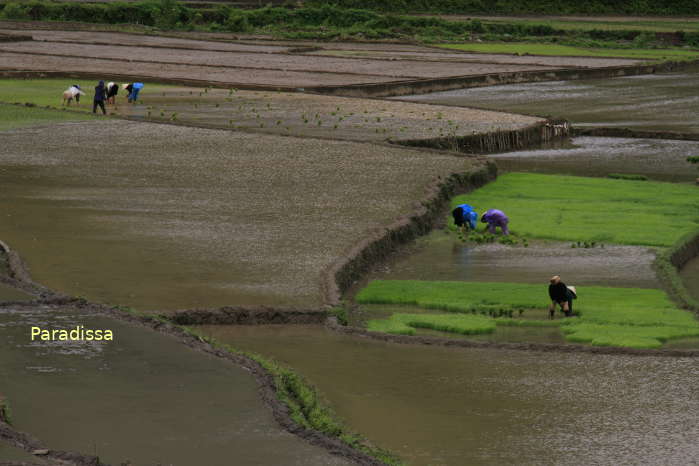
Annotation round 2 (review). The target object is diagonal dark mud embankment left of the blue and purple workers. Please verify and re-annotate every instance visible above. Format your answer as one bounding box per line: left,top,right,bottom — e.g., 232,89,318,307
322,161,497,306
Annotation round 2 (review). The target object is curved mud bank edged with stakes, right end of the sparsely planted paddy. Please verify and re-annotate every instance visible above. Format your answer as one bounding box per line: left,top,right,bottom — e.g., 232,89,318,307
395,120,570,154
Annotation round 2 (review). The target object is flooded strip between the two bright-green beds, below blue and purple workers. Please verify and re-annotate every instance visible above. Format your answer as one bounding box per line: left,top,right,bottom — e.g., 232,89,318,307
370,230,658,290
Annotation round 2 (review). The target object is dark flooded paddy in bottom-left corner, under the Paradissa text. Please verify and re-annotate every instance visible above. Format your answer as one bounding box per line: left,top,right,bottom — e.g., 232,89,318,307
0,308,343,466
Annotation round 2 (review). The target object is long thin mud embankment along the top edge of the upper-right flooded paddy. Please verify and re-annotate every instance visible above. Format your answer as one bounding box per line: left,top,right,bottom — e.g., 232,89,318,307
305,60,699,97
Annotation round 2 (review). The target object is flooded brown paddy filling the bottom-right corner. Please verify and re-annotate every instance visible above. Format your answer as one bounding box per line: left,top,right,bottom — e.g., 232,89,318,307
197,326,699,465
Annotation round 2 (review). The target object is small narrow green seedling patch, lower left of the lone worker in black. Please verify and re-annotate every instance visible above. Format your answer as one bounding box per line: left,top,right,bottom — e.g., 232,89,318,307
367,313,495,335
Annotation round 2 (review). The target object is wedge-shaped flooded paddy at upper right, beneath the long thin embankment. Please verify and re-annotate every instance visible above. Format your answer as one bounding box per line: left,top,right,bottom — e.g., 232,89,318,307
400,71,699,133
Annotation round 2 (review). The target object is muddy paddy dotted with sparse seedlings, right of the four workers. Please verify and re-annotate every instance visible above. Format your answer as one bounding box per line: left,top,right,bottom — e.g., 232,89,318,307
111,85,543,142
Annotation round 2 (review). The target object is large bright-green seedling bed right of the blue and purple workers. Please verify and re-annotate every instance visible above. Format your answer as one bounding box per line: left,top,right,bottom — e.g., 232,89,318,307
452,173,699,246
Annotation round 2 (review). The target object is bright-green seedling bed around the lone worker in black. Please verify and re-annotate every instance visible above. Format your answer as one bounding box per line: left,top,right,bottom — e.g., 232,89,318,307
356,280,699,348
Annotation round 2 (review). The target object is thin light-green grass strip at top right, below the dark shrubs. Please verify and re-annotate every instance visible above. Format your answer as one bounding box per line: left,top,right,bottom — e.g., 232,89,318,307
437,42,699,60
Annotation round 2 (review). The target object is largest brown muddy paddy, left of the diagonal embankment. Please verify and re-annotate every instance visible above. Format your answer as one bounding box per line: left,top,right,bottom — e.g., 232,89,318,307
0,121,483,309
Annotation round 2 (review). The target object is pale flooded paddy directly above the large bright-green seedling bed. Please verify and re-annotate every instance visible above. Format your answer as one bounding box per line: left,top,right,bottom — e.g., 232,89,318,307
491,137,699,182
